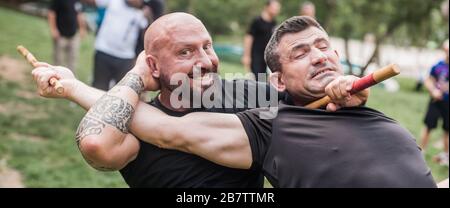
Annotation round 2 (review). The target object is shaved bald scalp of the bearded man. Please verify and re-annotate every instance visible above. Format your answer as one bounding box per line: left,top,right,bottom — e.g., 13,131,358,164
144,12,206,55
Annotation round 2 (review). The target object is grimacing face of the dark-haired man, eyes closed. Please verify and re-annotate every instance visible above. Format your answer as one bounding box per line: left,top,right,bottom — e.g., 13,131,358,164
278,27,343,101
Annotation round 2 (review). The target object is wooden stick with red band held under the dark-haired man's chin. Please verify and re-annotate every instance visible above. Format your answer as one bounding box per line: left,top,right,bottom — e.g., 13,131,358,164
305,64,400,109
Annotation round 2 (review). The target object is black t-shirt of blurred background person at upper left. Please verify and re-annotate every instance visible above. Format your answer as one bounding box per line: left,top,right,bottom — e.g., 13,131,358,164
50,0,81,37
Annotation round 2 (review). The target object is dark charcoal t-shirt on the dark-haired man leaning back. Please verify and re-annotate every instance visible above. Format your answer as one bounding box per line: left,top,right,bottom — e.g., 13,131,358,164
237,101,436,188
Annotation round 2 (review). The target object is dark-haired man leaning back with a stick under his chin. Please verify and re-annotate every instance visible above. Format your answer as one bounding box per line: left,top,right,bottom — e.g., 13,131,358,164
80,16,436,188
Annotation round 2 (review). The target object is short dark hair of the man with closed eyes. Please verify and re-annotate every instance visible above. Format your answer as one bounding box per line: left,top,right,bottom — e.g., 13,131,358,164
264,16,325,72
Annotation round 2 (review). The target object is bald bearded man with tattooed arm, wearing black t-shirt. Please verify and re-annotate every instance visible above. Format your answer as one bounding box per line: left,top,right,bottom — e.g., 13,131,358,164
33,13,288,188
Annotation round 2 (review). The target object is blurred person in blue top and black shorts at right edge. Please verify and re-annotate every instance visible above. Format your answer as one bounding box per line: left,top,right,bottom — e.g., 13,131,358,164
421,40,449,166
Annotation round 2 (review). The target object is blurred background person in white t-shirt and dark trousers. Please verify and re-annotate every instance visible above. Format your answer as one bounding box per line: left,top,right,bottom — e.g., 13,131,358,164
81,0,151,90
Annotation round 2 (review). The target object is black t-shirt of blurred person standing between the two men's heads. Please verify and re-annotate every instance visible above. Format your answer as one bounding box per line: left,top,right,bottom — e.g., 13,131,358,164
247,16,277,61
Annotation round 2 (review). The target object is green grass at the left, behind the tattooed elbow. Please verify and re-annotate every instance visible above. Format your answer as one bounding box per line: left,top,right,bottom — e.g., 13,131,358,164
0,8,127,187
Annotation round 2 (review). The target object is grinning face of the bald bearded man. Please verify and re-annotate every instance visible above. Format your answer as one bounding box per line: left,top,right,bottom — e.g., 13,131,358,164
157,22,219,93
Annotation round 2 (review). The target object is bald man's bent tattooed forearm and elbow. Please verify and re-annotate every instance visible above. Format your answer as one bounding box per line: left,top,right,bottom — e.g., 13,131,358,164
76,73,144,171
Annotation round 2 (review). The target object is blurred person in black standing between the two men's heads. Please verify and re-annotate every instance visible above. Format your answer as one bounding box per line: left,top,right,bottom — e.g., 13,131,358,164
242,0,281,81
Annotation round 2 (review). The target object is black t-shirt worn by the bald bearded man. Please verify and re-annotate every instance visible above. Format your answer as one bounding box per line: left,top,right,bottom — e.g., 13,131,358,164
120,80,273,188
